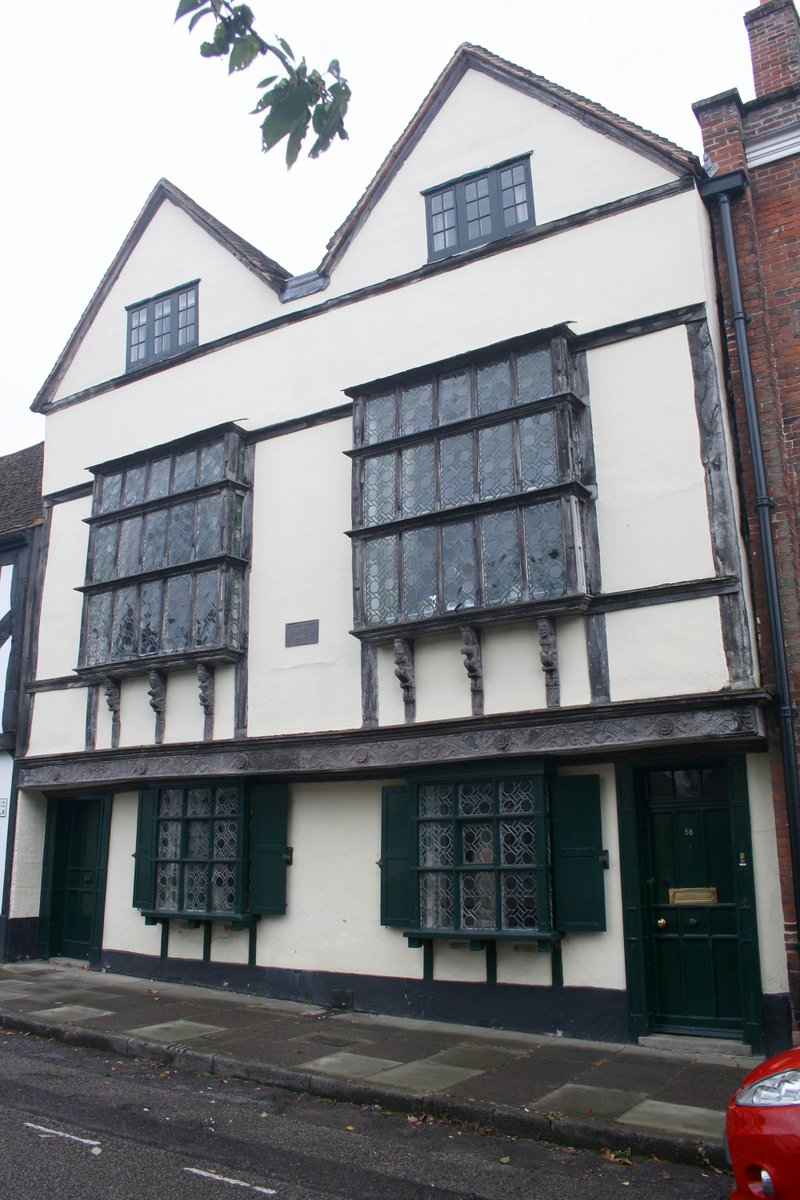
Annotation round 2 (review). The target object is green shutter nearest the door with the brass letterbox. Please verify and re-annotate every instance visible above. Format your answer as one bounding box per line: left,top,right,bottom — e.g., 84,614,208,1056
551,775,606,932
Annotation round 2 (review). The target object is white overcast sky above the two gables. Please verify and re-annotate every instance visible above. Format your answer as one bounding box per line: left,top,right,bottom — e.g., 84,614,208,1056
0,0,756,454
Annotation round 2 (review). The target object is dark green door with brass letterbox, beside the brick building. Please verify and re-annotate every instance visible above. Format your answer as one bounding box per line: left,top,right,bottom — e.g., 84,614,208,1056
643,767,742,1037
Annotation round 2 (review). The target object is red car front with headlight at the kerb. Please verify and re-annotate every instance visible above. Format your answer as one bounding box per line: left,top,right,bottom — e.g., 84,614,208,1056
726,1049,800,1200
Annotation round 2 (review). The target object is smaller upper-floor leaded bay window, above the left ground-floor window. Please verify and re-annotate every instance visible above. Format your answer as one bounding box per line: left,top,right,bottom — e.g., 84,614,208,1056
80,430,248,670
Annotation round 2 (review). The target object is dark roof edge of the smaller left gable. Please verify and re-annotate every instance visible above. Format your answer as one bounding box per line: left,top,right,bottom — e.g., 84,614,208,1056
31,179,290,413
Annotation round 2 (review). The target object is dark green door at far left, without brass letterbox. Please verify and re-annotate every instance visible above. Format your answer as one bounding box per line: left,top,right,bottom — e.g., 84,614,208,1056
43,797,110,961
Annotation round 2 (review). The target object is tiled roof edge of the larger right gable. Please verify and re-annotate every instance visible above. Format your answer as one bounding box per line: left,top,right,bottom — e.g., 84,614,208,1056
319,42,700,275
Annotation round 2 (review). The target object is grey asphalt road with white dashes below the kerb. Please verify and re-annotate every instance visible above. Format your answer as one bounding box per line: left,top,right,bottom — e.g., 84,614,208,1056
0,1031,729,1200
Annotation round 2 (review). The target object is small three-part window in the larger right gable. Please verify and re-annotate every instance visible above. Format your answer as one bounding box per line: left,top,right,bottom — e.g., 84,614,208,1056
423,157,534,259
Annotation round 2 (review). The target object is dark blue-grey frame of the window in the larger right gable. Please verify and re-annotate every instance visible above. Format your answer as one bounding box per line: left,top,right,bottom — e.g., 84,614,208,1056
422,151,536,263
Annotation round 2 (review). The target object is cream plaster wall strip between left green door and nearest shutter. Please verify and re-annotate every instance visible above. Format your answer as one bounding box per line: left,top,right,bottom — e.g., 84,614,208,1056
103,792,161,955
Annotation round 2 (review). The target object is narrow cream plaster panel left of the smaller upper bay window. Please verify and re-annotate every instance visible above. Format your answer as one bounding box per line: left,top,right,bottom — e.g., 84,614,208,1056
36,499,91,679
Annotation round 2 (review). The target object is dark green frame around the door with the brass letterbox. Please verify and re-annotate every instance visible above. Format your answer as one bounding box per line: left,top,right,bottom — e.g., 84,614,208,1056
616,755,764,1052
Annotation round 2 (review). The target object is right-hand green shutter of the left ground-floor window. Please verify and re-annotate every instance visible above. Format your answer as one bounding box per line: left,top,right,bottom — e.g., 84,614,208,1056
249,784,289,917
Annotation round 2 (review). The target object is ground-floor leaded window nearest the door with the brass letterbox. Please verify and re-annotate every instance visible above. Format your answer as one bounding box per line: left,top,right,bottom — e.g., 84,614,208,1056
416,775,551,937
